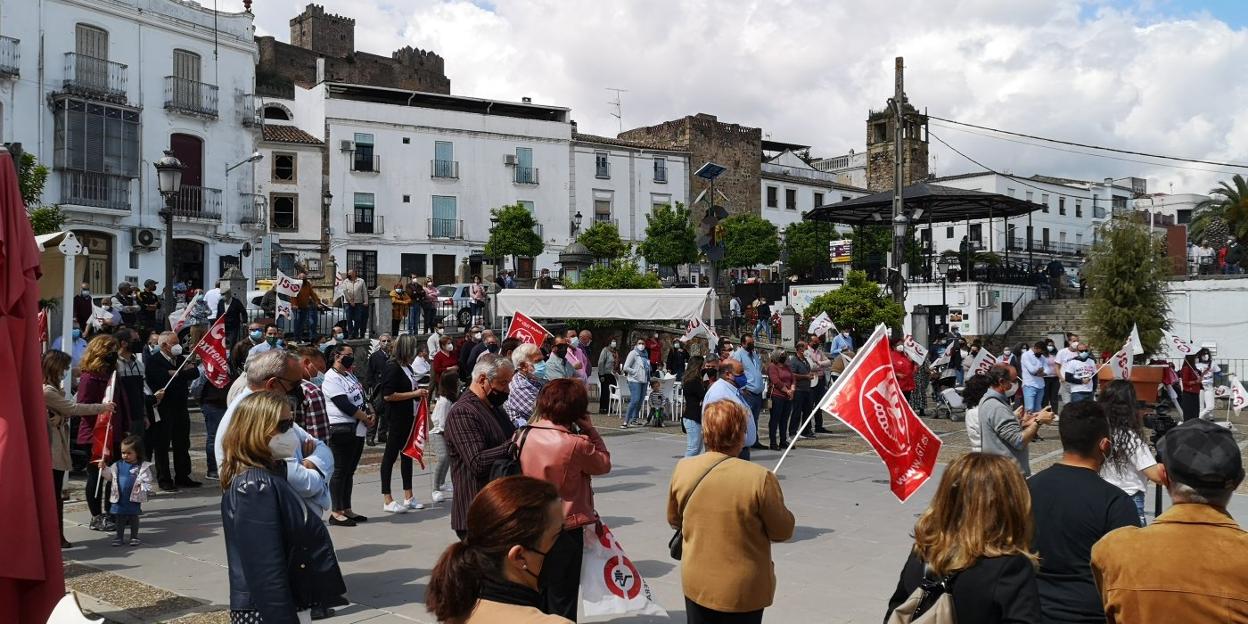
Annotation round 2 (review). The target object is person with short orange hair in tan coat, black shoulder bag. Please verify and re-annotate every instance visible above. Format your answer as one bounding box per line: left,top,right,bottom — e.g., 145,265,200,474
668,401,794,624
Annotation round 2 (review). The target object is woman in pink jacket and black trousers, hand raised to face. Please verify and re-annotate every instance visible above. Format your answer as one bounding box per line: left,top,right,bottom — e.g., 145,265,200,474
520,378,612,622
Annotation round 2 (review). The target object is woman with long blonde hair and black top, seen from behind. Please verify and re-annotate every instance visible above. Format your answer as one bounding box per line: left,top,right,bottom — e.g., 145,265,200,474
885,453,1041,624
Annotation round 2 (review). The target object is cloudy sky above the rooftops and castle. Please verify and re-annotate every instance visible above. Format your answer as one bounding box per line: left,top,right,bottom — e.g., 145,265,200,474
253,0,1248,192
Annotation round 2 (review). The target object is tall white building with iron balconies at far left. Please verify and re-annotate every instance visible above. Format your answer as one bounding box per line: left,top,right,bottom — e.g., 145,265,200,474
0,0,258,293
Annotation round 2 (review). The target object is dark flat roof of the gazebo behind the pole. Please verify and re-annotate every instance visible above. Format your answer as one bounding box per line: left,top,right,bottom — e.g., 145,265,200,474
802,182,1041,226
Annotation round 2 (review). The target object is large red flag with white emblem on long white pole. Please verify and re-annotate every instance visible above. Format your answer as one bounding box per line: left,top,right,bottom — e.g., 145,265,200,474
819,324,938,503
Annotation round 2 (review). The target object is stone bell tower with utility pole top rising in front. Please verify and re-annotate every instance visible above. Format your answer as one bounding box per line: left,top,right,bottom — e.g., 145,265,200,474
866,56,927,192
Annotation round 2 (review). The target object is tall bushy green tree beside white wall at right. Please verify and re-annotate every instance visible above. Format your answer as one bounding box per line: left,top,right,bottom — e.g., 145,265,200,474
1083,217,1171,354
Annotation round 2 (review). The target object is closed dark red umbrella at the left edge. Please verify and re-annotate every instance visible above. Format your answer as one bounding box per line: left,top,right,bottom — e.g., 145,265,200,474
0,149,65,623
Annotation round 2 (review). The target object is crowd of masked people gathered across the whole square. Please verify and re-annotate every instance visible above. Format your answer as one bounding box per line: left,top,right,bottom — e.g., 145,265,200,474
42,281,1248,623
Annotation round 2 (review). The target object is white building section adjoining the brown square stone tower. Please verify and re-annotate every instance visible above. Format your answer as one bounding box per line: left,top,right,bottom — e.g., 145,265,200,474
570,134,690,243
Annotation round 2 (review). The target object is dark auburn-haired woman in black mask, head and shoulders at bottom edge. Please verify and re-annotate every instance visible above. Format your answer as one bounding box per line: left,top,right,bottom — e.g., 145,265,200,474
424,475,572,624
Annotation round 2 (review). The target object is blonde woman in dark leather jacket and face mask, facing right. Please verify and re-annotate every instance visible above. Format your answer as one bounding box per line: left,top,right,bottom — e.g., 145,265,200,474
221,392,347,624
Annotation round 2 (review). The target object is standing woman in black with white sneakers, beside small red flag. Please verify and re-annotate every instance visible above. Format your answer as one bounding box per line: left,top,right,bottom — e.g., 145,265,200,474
377,333,429,513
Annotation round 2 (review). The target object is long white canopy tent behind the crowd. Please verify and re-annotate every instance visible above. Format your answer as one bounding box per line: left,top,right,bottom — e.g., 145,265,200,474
497,288,714,321
